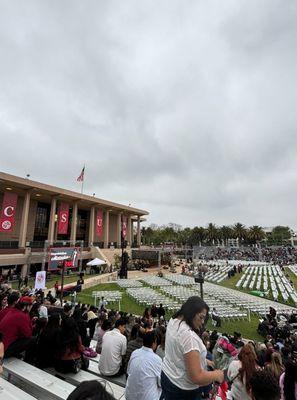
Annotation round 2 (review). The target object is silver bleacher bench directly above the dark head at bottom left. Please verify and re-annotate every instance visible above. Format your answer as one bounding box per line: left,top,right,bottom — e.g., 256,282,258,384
46,363,125,400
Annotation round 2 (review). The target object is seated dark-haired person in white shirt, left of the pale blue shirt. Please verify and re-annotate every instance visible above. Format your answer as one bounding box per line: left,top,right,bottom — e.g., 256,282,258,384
98,318,127,376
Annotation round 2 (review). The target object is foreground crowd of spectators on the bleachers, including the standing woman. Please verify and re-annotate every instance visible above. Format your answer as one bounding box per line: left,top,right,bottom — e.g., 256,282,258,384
0,276,297,400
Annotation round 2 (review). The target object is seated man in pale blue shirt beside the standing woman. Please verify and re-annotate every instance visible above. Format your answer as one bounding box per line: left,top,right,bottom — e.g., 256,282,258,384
125,331,162,400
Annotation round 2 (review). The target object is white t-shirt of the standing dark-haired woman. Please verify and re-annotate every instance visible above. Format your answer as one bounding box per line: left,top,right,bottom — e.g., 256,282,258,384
162,318,207,390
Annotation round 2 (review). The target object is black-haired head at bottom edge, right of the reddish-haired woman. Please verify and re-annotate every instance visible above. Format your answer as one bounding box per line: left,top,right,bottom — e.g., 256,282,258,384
250,369,280,400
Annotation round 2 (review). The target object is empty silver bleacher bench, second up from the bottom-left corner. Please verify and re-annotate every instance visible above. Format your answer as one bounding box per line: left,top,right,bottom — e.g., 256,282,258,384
3,357,75,400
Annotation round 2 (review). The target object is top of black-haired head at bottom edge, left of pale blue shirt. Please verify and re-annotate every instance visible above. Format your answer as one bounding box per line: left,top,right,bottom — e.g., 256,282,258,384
67,380,115,400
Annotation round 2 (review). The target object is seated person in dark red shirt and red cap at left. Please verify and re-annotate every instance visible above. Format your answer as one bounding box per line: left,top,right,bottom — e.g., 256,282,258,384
0,296,36,362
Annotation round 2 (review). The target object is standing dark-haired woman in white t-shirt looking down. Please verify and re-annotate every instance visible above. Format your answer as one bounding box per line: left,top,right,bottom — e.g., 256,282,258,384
161,296,224,400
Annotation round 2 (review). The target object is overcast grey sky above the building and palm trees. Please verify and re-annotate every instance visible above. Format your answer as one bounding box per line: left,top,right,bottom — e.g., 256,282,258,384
0,0,297,228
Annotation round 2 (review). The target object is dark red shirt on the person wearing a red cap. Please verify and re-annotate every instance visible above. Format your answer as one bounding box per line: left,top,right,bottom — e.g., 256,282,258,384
0,308,32,349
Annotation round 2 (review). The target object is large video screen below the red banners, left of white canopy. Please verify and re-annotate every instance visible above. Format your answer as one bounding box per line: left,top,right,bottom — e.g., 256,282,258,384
48,247,81,270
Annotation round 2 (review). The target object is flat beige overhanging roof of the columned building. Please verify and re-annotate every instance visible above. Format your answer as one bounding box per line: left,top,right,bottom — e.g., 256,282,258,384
0,171,149,216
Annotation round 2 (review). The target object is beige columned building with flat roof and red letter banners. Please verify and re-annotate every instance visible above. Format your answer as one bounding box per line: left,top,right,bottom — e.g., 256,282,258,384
0,172,148,276
